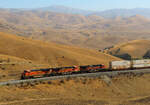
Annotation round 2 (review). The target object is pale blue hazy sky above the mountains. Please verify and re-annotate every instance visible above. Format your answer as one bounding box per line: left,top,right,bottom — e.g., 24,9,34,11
0,0,150,11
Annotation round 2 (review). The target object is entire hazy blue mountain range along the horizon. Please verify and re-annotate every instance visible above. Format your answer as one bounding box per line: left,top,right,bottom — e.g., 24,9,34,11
34,5,150,18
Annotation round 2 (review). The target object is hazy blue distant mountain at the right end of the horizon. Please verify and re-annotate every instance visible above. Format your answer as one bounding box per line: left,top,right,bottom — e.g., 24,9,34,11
92,8,150,18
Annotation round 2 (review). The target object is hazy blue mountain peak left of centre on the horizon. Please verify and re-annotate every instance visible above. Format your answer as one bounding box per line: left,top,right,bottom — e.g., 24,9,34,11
35,5,94,15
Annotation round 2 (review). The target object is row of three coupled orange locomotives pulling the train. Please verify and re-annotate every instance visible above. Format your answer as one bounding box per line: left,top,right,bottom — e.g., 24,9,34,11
21,64,105,79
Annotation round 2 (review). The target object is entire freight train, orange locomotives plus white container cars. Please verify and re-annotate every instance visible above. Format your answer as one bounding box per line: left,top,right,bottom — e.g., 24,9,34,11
21,59,150,79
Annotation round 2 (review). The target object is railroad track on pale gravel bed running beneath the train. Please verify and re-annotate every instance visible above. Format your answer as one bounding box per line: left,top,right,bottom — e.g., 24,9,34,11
0,69,150,86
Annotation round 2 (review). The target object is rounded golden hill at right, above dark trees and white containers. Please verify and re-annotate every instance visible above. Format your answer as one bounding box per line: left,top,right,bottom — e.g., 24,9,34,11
108,40,150,58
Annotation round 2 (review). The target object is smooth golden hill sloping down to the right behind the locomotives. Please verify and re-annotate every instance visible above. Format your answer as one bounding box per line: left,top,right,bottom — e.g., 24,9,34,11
0,32,118,66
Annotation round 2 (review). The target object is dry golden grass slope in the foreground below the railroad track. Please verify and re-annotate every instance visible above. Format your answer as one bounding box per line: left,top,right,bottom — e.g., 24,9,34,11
0,74,150,105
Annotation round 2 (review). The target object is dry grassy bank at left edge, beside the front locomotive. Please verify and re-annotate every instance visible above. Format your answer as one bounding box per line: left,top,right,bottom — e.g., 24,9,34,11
0,54,49,82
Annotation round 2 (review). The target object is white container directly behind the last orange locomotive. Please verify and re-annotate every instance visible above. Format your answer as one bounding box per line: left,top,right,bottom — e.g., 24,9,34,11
109,60,131,70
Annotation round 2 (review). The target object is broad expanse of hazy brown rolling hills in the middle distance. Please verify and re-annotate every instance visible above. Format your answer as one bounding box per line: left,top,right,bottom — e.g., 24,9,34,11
0,9,150,49
